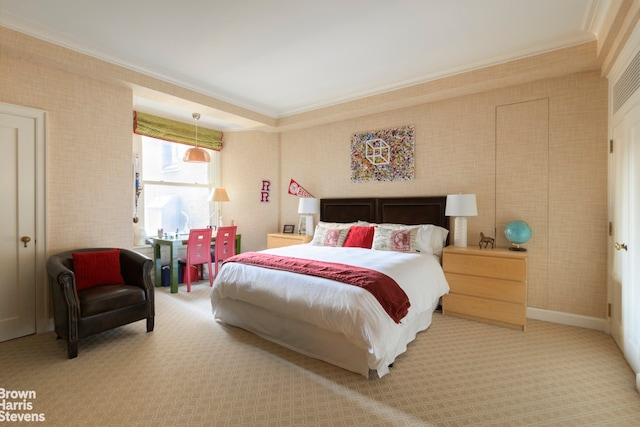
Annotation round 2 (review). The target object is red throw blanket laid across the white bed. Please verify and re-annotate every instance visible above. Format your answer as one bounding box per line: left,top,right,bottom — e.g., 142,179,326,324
225,252,411,323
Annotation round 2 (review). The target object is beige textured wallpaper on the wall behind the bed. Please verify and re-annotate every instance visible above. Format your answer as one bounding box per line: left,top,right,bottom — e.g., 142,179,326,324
280,72,607,318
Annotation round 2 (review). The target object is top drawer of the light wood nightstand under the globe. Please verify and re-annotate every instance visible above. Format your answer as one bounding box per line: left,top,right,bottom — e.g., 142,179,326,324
443,253,527,282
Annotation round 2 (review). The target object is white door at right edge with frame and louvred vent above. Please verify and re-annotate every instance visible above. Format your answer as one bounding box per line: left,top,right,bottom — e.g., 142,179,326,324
608,23,640,380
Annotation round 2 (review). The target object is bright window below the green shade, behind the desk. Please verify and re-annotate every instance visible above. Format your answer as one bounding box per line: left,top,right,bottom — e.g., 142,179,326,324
141,136,218,236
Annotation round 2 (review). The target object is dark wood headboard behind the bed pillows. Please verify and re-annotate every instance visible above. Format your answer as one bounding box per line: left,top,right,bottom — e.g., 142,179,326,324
320,196,449,230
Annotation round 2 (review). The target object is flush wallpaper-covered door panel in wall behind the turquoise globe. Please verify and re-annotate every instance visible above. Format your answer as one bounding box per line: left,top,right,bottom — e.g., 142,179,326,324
496,98,549,308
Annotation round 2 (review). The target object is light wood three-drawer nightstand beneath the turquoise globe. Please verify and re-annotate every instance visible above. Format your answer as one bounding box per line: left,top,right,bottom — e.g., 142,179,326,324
442,246,527,330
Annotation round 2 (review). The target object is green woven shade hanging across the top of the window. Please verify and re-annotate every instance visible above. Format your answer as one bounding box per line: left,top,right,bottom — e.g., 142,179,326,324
133,111,222,151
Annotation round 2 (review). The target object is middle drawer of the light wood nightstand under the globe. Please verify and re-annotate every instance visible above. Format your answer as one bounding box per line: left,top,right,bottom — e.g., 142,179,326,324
445,273,527,304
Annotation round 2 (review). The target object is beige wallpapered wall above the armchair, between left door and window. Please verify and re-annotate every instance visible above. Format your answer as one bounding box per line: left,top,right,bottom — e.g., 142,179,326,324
0,36,133,253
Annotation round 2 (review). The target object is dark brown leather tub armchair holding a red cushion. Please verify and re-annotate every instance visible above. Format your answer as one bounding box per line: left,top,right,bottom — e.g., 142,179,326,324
47,248,155,359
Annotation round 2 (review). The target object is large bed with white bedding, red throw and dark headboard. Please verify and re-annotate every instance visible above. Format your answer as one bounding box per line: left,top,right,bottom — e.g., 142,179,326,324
211,196,449,377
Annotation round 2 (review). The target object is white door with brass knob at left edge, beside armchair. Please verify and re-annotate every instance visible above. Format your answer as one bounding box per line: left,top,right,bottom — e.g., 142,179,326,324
0,112,36,341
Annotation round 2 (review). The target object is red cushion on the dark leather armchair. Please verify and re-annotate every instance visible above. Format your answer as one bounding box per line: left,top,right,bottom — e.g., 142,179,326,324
71,249,124,290
